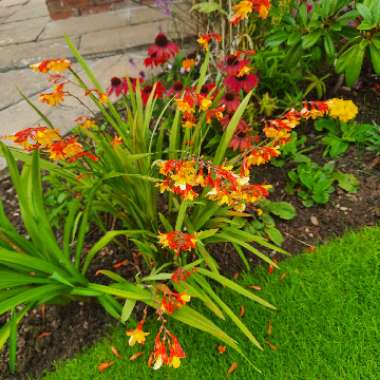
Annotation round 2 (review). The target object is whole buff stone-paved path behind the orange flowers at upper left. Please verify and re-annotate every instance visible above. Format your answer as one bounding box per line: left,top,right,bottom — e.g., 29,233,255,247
0,0,193,170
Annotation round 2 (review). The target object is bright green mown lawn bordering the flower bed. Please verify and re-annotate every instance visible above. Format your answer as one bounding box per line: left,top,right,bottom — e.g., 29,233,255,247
44,228,380,380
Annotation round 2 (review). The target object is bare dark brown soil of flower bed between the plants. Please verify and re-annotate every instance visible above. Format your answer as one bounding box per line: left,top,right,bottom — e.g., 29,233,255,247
0,90,380,380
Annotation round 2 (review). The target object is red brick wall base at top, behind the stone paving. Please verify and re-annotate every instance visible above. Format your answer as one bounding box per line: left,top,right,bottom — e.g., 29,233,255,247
46,0,132,20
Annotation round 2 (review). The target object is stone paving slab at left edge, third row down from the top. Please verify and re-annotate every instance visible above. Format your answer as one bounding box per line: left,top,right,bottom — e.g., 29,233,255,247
0,38,79,71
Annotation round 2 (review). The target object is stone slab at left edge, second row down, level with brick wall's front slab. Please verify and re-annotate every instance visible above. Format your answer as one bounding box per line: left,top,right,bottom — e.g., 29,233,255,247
0,17,49,46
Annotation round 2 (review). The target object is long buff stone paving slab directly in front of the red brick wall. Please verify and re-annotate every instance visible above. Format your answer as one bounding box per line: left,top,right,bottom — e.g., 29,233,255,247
39,6,167,40
